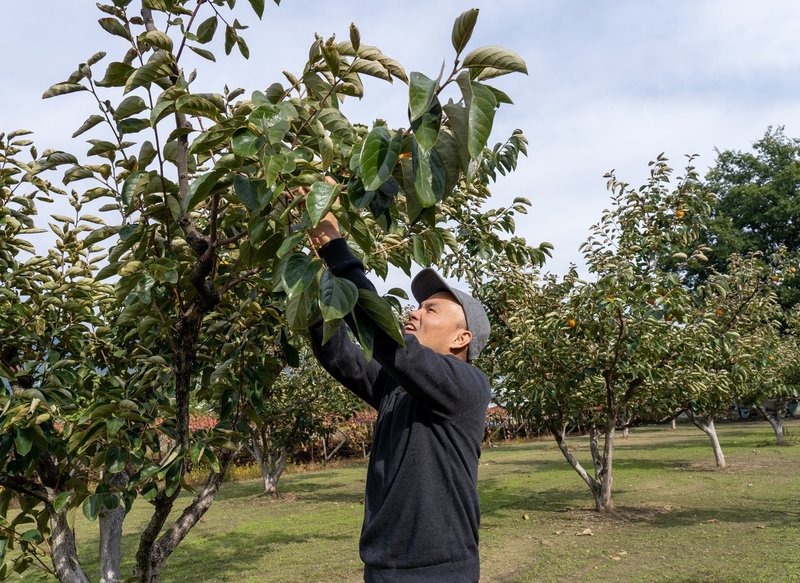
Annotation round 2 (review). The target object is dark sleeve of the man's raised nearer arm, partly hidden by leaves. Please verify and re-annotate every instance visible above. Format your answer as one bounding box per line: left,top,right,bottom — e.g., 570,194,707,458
318,239,491,417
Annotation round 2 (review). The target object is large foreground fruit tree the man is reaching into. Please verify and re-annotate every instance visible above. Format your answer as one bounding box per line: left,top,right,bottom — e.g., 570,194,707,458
2,0,547,582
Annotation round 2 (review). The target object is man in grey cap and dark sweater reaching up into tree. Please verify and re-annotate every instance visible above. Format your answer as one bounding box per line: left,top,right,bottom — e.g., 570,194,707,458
310,214,491,583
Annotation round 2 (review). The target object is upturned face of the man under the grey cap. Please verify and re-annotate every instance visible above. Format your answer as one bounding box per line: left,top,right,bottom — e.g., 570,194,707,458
404,292,472,354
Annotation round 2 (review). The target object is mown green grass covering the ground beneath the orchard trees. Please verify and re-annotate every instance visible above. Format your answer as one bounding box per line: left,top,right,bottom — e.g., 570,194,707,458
10,420,800,583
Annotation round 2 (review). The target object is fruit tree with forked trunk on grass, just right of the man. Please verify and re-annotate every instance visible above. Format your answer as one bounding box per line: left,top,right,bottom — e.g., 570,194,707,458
488,157,711,511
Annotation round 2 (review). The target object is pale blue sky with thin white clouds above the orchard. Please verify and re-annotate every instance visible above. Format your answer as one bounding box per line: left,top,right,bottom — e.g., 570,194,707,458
0,0,800,289
